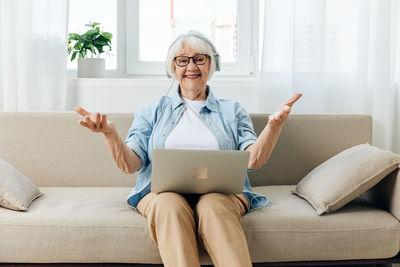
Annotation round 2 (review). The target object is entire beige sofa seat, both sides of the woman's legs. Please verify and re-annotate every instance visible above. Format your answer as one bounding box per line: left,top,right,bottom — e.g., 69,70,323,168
0,186,400,264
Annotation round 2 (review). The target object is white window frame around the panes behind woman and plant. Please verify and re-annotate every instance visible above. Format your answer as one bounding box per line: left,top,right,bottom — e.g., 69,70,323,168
68,0,260,79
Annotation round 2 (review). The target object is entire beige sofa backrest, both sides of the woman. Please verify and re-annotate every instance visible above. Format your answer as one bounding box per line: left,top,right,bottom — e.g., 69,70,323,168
0,112,372,187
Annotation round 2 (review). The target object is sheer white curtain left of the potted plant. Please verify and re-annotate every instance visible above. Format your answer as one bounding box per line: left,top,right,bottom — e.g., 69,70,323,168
0,0,68,111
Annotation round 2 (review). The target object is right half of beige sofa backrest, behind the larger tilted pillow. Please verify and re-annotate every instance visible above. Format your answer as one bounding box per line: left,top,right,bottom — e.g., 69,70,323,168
249,114,372,186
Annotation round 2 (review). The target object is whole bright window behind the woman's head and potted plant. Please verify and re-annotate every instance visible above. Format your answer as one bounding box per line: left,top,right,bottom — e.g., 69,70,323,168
68,0,259,77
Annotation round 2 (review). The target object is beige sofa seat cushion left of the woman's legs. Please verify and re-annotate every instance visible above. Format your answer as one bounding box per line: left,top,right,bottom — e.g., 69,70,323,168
0,187,161,263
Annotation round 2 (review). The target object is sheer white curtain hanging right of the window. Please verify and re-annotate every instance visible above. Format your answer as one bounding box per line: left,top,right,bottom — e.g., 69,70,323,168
259,0,400,153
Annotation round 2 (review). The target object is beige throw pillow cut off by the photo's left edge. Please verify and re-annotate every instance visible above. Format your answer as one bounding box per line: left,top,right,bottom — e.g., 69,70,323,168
0,159,42,211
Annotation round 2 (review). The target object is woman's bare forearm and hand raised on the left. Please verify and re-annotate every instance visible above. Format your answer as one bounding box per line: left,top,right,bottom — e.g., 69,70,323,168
74,107,142,173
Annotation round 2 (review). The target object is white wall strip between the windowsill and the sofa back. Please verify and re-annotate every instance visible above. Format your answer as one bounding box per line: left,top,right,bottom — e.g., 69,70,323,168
68,78,259,113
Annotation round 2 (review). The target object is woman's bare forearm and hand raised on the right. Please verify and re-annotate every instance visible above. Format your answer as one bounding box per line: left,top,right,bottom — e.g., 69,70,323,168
246,94,302,169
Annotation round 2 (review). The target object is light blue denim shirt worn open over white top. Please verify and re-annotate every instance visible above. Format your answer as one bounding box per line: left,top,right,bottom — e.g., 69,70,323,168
125,86,268,211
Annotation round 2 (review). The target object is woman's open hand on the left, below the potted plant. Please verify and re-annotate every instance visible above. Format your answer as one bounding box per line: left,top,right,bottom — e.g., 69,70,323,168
74,107,115,134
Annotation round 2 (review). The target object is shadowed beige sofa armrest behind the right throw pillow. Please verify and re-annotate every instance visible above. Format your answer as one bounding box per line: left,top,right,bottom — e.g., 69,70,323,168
362,169,400,221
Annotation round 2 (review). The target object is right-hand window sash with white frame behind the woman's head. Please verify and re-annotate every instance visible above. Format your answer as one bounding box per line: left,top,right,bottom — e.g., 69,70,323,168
126,0,258,76
